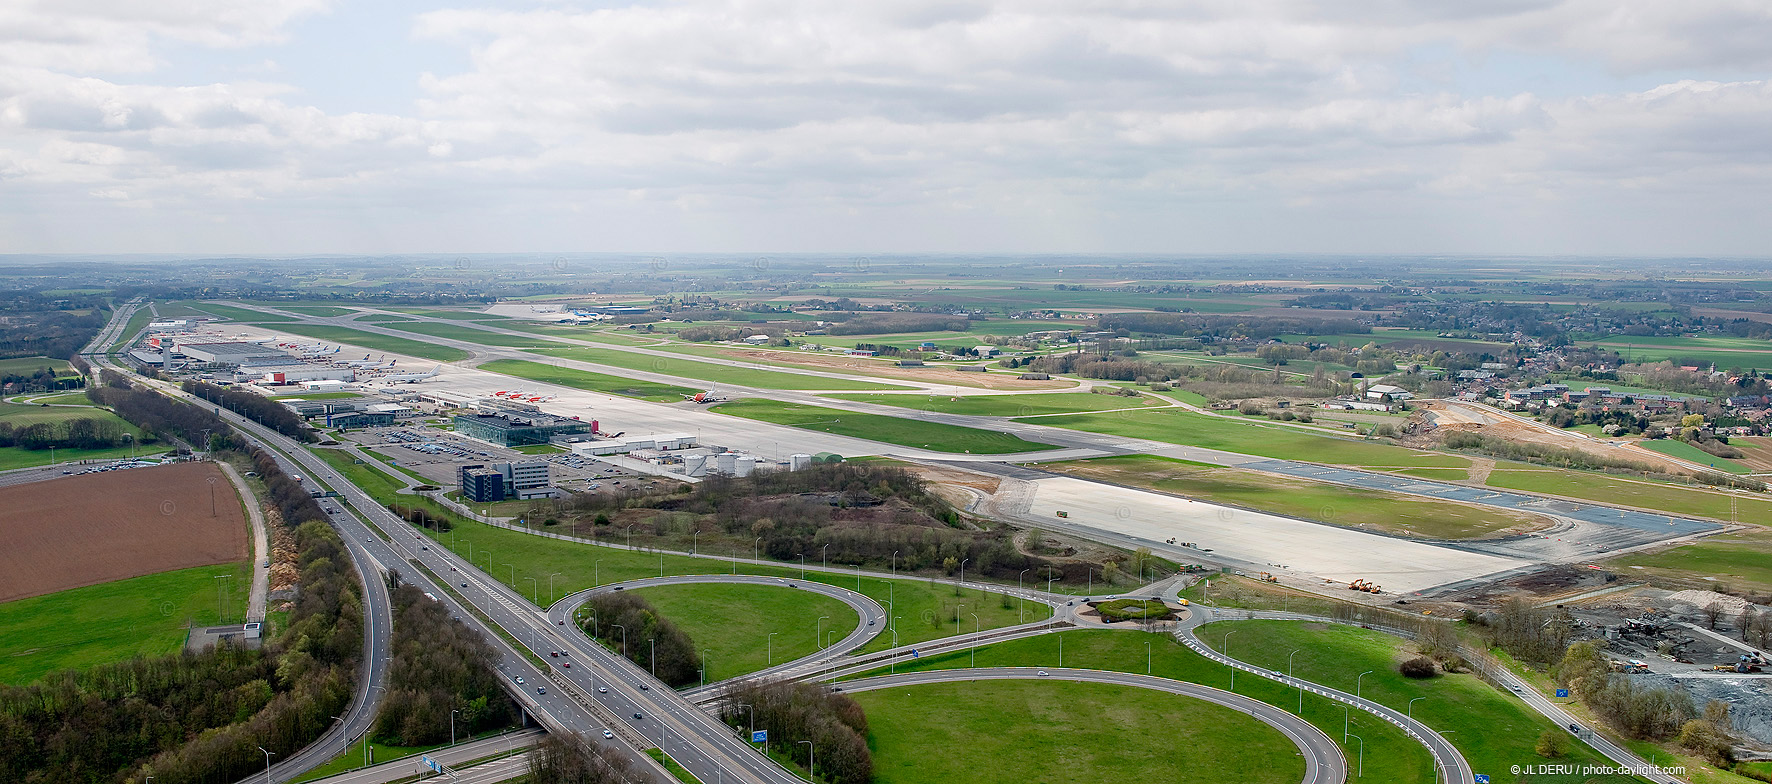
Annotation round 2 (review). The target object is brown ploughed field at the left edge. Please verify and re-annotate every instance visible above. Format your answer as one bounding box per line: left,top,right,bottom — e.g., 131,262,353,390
0,463,248,601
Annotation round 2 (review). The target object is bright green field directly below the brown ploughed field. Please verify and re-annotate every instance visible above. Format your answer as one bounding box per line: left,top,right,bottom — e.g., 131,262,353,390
0,562,252,685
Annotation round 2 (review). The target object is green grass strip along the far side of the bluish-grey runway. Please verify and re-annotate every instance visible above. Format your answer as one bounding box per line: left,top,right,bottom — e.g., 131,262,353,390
1030,408,1471,468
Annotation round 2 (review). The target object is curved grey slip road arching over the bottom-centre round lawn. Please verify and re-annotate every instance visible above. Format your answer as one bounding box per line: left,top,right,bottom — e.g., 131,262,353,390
842,667,1339,784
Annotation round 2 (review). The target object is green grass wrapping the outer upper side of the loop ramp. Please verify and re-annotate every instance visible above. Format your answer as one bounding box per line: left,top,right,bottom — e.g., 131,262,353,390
418,517,1051,653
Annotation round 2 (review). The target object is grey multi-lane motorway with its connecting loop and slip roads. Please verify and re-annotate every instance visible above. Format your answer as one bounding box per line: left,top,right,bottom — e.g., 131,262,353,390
76,307,1694,784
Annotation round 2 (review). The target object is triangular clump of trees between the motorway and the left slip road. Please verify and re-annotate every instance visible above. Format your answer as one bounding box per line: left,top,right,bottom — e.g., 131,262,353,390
374,571,516,747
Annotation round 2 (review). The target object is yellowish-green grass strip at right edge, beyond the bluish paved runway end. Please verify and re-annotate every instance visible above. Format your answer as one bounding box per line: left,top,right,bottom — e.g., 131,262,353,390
1488,463,1772,521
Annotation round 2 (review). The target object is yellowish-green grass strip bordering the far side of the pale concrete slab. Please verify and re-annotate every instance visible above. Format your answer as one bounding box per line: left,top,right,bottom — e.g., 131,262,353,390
1042,454,1551,539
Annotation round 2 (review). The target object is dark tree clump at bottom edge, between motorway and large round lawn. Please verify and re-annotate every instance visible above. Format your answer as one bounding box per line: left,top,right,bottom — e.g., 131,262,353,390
719,681,874,784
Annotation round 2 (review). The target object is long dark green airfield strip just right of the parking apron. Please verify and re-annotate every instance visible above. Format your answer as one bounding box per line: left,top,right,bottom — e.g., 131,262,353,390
712,397,1058,454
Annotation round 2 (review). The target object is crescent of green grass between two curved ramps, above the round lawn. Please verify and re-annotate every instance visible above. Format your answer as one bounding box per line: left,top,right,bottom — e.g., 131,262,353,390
856,630,1435,784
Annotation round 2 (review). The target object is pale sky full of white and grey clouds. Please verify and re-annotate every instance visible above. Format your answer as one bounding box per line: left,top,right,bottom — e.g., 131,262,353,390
0,0,1772,255
